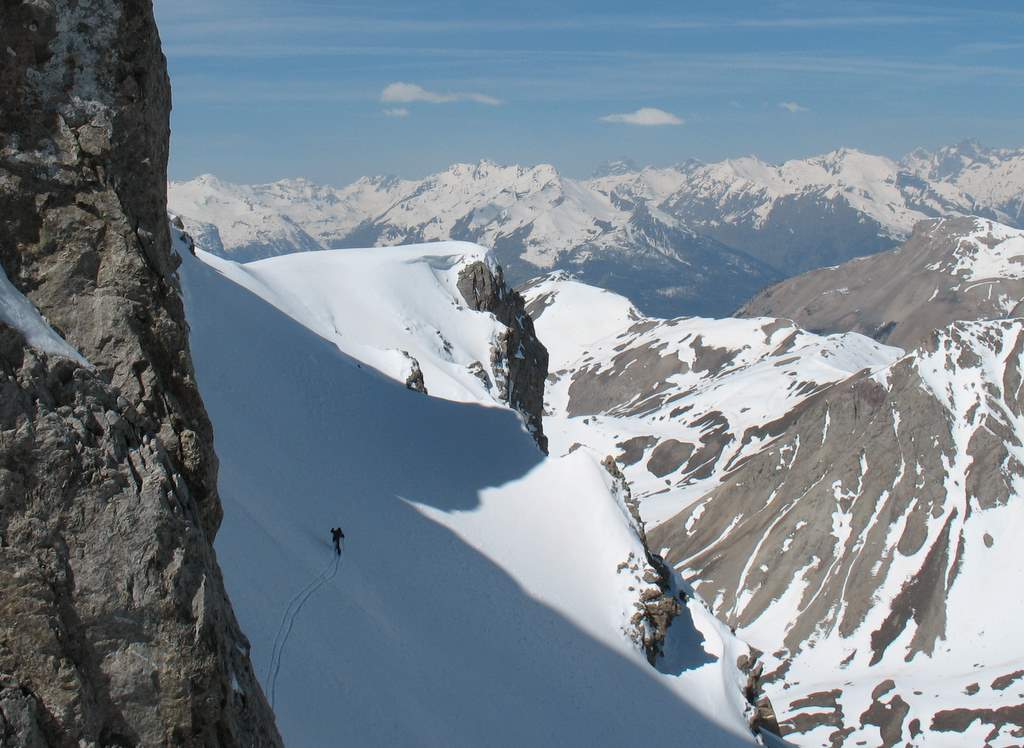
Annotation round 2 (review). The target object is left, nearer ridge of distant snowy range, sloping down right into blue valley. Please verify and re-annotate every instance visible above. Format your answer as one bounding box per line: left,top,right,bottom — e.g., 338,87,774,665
169,161,780,314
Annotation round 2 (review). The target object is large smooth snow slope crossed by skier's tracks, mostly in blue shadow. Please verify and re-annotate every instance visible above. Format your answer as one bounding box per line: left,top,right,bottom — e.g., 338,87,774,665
174,241,752,746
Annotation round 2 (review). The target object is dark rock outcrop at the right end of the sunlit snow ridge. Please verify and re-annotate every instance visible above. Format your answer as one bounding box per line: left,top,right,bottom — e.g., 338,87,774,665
458,262,548,452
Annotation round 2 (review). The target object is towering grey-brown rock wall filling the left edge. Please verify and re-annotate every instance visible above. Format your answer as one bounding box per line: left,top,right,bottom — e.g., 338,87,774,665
0,0,280,745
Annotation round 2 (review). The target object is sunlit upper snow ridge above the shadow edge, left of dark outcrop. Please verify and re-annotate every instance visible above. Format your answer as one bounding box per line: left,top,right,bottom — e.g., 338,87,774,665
192,242,501,404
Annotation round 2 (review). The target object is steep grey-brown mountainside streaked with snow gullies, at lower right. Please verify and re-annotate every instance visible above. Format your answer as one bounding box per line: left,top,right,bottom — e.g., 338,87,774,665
651,320,1024,746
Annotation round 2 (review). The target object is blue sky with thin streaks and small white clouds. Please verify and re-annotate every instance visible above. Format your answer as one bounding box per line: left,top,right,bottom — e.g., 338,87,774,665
155,0,1024,184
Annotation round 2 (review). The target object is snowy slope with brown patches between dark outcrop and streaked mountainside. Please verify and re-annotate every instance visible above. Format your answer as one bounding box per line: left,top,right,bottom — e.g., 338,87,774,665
524,275,902,525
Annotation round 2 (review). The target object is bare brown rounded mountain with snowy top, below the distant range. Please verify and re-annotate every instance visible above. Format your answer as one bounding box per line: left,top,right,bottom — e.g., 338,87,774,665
738,218,1024,347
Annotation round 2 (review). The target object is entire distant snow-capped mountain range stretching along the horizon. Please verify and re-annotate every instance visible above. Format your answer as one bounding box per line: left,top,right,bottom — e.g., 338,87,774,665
169,141,1024,317
